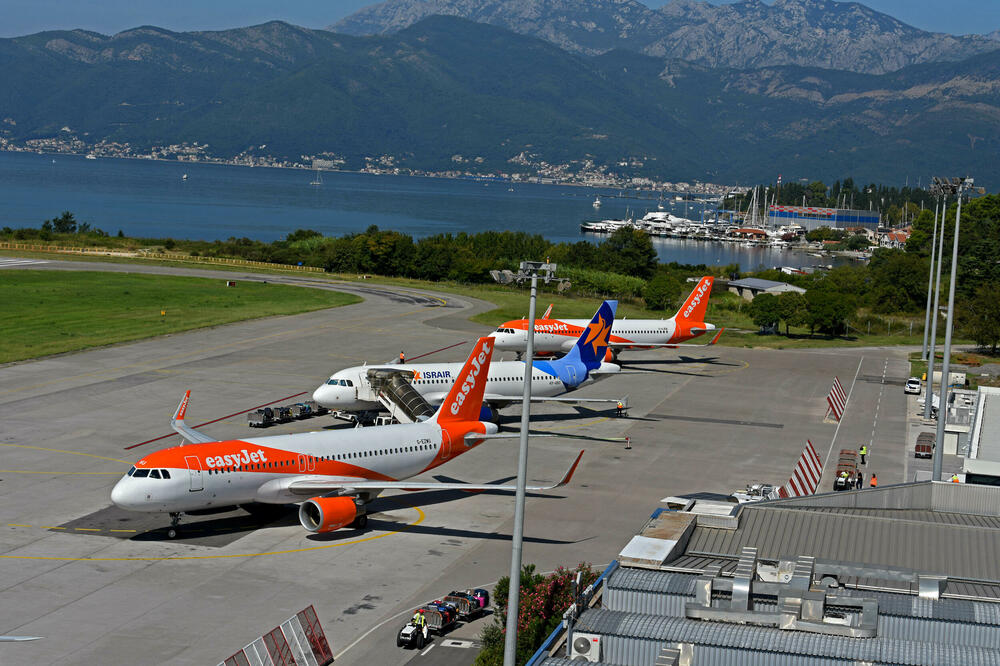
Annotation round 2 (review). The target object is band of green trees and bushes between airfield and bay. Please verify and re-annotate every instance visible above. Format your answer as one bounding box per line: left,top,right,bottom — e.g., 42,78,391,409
0,196,1000,350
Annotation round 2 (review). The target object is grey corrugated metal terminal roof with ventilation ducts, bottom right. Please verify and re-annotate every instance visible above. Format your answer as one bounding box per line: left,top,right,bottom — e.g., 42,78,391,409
539,482,1000,666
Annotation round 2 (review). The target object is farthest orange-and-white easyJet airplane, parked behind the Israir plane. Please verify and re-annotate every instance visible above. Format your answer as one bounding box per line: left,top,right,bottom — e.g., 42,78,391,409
490,276,725,361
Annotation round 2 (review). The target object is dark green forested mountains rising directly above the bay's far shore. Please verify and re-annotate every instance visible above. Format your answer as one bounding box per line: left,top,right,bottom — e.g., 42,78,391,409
0,6,1000,185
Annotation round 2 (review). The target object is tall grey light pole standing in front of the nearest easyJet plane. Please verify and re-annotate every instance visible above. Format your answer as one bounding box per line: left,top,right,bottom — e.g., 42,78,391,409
490,261,569,666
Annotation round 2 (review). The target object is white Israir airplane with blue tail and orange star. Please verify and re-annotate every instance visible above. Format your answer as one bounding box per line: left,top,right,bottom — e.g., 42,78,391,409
313,301,621,420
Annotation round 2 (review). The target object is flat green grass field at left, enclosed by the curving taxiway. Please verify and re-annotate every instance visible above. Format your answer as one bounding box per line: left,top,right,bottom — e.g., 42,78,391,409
0,270,361,363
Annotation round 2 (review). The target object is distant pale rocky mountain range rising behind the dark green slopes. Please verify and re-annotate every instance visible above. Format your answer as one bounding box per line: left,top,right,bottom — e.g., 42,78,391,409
330,0,1000,74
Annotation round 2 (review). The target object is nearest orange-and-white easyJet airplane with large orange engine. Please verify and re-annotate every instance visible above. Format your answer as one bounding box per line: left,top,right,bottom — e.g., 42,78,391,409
111,338,583,538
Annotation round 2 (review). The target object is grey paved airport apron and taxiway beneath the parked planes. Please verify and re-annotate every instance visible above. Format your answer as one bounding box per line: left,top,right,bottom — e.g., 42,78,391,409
0,262,907,666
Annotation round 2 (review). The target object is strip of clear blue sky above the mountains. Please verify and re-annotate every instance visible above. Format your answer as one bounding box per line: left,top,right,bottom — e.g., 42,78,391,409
0,0,1000,37
